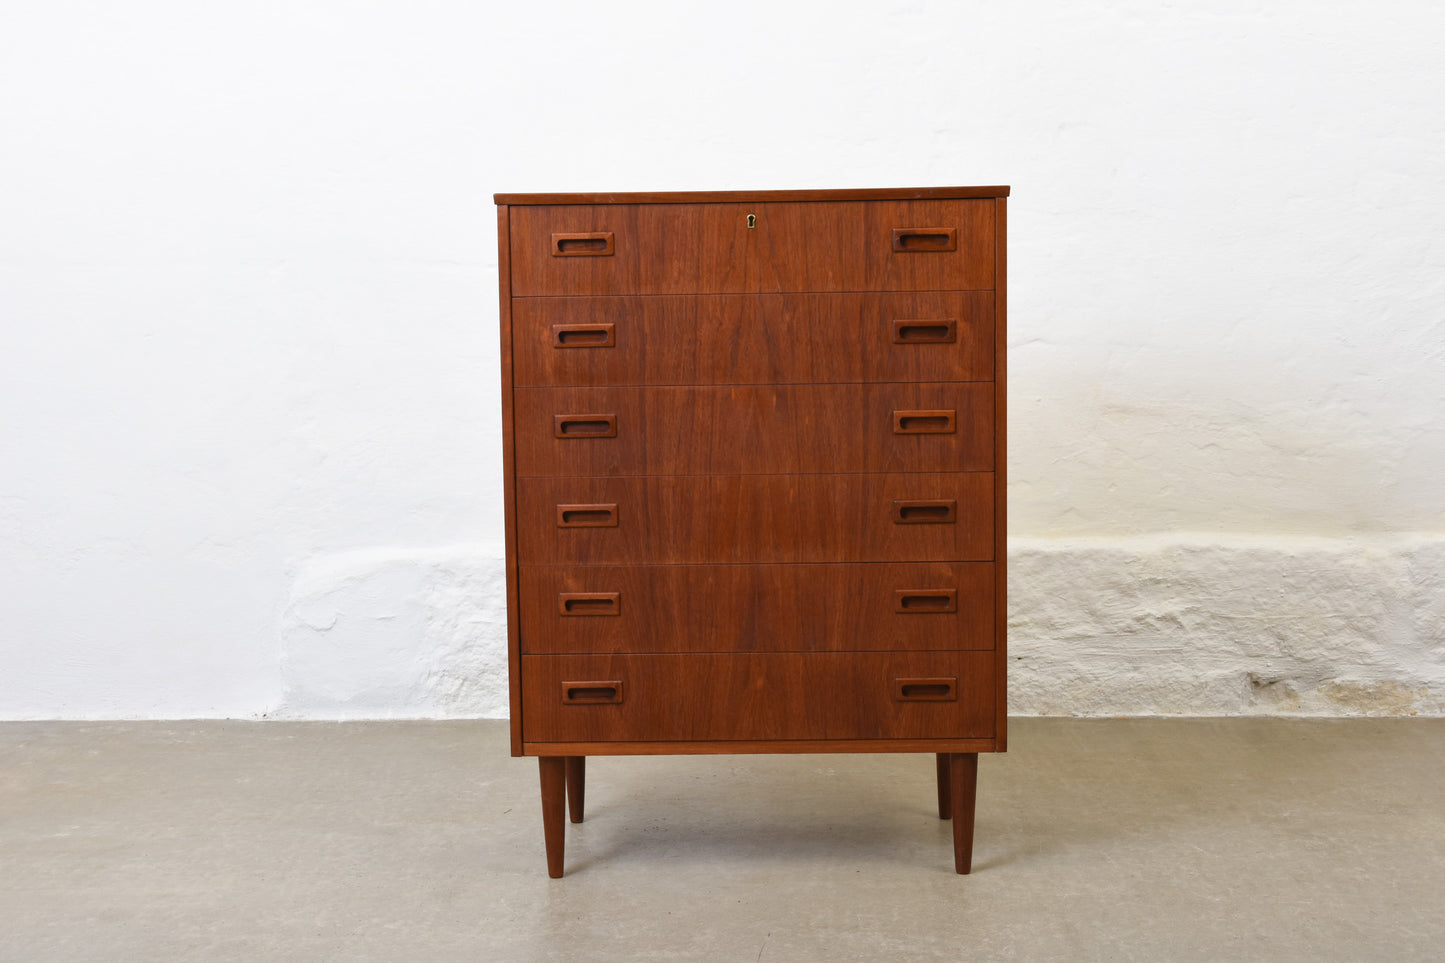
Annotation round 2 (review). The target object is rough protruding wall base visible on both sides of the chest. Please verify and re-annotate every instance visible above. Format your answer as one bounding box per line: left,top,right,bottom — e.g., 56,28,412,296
279,538,1445,717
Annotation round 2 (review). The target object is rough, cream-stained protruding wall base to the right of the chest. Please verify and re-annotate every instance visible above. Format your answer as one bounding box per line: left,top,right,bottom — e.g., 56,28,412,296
1009,536,1445,716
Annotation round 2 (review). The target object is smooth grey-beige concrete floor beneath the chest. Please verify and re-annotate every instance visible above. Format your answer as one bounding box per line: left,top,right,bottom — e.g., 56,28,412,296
0,719,1445,963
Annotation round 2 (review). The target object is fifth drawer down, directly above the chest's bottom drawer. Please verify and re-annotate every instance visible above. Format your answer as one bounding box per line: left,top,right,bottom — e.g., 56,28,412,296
517,562,994,655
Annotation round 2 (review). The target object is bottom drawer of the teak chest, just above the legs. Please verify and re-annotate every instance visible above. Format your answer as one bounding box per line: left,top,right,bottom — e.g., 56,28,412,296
522,652,994,743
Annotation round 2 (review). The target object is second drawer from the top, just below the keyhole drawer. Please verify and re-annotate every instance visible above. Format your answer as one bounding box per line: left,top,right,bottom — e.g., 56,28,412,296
512,291,994,386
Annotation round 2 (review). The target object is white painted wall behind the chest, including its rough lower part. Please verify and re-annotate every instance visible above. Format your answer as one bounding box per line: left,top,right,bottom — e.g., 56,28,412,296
0,0,1445,717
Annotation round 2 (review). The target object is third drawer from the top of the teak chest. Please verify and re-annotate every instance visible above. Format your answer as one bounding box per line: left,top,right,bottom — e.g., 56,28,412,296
513,382,994,477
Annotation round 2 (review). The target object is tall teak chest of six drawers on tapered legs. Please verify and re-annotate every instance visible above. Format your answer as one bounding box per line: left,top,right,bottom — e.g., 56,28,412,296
496,187,1009,876
